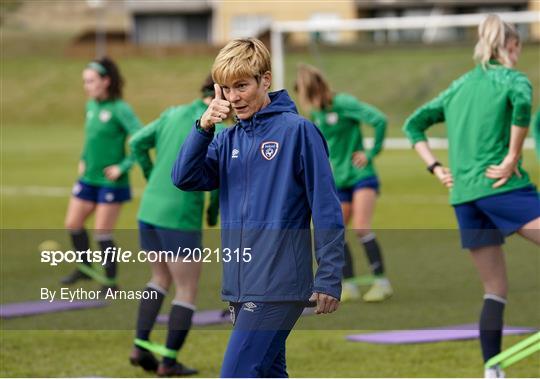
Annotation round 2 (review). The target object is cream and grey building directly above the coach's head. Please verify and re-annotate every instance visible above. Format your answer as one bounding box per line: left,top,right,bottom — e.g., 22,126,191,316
126,0,356,45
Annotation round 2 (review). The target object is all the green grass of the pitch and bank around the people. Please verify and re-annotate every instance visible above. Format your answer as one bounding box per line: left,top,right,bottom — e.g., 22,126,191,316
0,34,540,377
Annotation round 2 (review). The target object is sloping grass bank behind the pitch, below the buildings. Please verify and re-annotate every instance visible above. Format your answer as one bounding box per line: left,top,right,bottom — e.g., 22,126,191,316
2,32,540,137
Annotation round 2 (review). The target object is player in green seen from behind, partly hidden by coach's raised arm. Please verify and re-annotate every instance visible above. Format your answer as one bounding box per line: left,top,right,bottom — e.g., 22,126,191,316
130,76,218,376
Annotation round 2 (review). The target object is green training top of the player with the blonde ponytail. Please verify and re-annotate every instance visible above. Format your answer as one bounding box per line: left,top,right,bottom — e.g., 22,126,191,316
403,61,532,205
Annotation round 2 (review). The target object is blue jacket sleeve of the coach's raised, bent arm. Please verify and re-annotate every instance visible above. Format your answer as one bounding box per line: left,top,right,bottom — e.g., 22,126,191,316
171,125,219,191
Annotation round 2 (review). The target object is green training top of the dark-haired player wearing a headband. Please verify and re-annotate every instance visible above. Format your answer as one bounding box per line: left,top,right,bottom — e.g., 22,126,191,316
79,99,142,187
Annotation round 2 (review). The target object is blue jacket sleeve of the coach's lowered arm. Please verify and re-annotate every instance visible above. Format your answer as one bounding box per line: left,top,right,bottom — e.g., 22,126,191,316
301,123,345,299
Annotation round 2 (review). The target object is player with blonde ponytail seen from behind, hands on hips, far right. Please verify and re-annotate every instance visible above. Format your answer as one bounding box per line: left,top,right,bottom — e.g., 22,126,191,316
403,15,540,378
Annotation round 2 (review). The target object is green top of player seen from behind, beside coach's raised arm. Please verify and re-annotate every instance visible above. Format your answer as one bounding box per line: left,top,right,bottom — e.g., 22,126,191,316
129,99,217,230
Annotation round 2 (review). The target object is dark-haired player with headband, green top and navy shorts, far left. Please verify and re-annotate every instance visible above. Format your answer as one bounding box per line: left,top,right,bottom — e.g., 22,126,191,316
62,58,141,289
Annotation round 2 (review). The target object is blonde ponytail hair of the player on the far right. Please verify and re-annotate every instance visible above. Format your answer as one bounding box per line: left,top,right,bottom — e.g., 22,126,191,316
474,14,520,69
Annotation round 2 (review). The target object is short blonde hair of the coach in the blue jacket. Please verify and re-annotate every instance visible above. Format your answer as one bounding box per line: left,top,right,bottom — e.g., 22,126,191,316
212,38,272,84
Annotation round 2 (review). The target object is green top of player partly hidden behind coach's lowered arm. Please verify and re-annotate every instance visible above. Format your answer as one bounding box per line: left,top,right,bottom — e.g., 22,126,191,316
311,93,386,189
